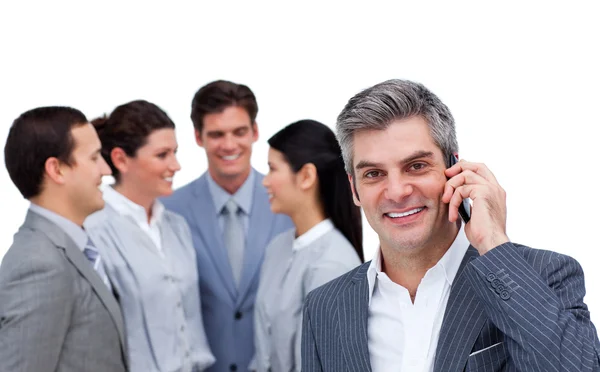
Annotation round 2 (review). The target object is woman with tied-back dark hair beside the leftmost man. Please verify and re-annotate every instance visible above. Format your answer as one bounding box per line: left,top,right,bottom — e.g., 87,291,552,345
84,101,214,372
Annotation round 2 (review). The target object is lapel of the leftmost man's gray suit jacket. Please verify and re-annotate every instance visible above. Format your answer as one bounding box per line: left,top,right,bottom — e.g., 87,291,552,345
26,212,126,349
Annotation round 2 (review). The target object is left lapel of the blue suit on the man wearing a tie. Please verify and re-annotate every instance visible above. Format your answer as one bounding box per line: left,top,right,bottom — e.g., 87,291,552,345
191,173,237,302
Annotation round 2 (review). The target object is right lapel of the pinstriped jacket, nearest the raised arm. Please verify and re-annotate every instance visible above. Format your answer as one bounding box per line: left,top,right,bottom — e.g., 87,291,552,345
433,246,487,372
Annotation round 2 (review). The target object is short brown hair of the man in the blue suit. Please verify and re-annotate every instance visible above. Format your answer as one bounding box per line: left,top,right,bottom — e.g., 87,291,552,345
190,80,258,132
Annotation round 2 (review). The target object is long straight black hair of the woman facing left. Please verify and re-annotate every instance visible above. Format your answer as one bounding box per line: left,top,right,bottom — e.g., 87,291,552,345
268,120,364,261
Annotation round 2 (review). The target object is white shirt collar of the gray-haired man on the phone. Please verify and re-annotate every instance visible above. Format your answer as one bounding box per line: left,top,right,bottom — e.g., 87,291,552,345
367,224,470,304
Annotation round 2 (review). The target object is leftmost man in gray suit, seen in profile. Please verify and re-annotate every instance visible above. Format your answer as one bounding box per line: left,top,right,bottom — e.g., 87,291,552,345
0,107,127,372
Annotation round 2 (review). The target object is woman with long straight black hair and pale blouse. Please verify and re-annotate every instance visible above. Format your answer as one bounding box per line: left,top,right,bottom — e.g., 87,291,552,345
250,120,363,372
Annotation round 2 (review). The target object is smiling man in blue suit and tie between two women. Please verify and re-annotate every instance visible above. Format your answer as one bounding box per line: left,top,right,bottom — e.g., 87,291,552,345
163,80,292,372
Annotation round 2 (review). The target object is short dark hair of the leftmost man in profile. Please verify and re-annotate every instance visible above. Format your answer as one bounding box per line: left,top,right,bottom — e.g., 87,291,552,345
4,106,88,199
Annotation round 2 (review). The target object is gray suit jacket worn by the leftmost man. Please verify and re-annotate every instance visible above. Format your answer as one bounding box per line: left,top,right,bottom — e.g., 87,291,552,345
0,212,127,372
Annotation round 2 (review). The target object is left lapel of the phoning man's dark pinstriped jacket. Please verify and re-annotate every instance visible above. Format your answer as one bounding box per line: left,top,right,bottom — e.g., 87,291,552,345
338,262,371,372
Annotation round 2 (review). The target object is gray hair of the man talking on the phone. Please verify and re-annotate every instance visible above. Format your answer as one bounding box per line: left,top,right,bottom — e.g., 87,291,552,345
336,79,458,175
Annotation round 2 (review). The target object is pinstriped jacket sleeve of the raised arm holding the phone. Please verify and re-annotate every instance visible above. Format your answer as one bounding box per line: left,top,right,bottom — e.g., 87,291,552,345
466,242,600,372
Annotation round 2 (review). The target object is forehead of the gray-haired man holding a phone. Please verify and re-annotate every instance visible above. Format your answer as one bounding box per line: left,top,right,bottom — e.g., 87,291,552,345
352,116,442,167
